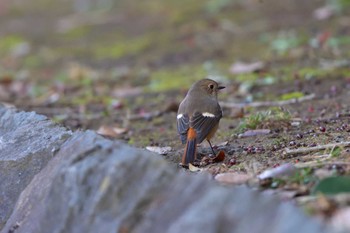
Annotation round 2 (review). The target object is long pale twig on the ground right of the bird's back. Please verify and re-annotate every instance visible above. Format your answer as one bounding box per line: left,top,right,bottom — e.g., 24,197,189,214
220,94,316,108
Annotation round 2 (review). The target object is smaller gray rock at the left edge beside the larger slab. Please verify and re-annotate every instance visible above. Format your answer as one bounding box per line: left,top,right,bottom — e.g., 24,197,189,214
0,105,71,229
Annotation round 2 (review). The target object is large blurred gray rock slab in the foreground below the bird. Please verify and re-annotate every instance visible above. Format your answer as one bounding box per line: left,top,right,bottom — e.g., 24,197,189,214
2,131,329,233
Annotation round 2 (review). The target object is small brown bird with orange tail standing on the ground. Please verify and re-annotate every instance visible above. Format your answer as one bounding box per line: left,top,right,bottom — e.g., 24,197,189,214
177,79,225,165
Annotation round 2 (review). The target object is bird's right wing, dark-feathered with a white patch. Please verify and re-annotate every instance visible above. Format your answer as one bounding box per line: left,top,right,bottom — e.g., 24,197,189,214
190,108,222,143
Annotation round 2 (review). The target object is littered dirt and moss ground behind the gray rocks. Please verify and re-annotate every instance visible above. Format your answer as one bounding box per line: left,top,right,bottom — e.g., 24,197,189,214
0,0,350,229
